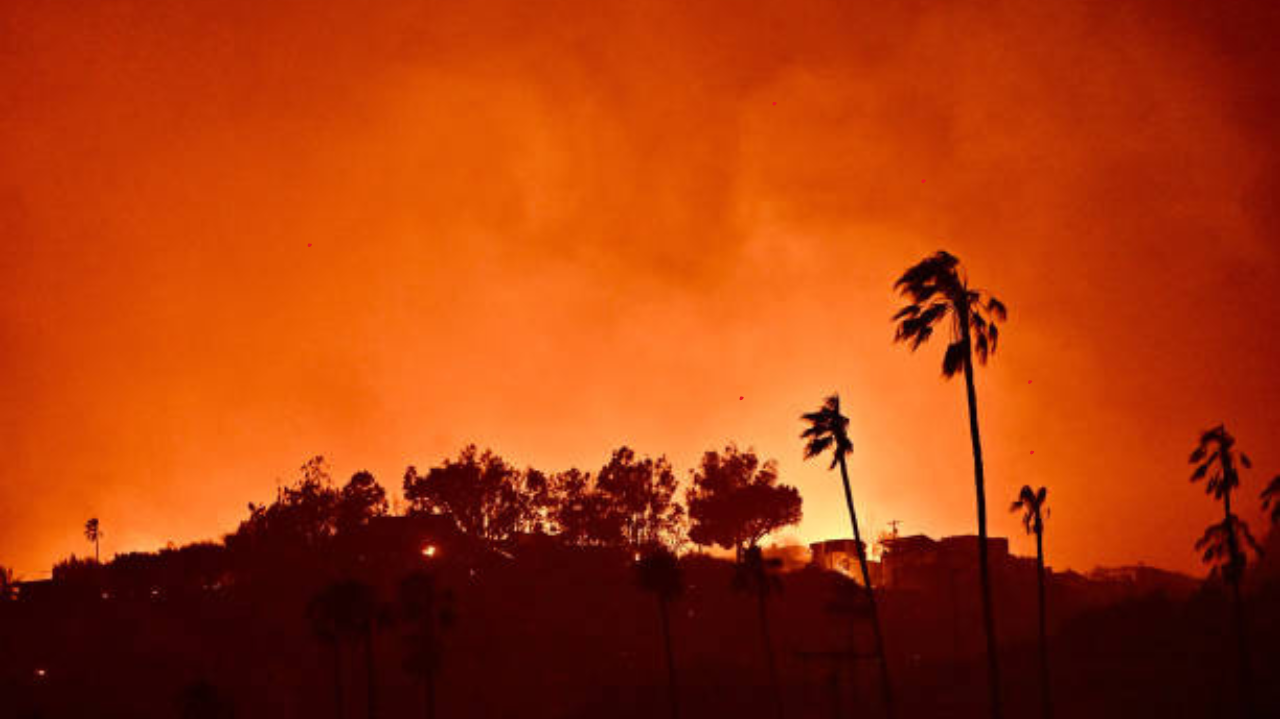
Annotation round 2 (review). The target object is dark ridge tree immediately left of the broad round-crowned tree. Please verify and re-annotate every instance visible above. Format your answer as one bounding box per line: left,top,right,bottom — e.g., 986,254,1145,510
595,446,685,549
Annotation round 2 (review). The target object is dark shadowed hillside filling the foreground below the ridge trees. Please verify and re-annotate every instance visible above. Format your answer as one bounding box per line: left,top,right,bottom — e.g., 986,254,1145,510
0,519,1280,718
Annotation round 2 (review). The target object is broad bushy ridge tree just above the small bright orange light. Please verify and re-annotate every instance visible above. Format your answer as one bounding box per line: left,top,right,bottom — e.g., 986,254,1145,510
404,444,525,541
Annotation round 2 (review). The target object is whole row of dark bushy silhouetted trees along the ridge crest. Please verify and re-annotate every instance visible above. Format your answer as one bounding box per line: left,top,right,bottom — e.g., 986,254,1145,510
228,444,803,553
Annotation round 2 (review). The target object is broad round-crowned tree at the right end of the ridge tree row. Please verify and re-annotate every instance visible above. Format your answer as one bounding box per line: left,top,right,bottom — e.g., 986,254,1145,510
685,445,801,558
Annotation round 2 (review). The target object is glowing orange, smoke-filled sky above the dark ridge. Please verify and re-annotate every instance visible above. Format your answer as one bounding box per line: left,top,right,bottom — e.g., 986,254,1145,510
0,0,1280,576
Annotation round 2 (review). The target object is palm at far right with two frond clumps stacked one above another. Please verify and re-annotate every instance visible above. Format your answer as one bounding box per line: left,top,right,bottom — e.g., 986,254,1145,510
1188,425,1271,716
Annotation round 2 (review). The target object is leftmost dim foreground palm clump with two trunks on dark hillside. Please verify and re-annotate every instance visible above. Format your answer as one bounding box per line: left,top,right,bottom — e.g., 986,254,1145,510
307,580,376,719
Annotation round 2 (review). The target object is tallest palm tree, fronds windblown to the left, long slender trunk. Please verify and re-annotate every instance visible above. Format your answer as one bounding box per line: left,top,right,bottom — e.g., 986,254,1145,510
893,251,1006,719
